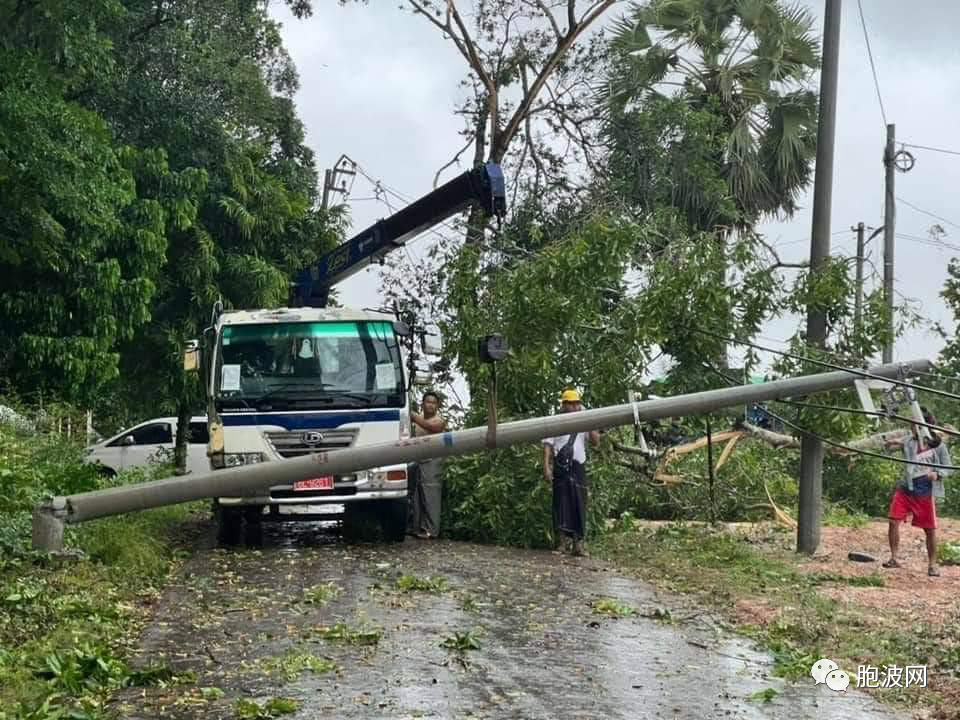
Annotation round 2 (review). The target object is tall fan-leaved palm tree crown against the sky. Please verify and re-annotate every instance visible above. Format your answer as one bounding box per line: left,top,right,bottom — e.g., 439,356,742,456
605,0,820,230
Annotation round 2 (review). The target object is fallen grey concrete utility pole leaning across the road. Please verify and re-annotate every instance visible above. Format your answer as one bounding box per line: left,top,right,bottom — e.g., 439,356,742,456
33,360,932,551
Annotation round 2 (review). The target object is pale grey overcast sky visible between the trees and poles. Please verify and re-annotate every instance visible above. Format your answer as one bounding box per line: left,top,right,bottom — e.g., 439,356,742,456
273,0,960,372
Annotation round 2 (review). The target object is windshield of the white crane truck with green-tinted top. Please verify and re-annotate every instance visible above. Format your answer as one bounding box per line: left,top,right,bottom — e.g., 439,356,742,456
216,322,403,408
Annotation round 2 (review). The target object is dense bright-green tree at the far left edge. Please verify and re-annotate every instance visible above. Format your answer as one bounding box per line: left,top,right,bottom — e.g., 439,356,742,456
0,2,188,402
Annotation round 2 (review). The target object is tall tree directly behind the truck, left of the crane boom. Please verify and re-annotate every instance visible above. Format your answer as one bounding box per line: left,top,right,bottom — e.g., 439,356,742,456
90,0,339,464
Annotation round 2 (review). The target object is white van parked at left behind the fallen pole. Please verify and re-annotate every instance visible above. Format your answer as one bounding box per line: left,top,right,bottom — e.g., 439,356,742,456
86,415,210,475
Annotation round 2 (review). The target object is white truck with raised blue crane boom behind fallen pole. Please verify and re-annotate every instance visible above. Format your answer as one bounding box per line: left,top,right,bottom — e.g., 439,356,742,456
185,163,506,543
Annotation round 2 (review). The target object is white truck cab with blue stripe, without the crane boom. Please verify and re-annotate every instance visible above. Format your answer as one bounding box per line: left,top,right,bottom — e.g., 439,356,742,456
206,307,410,542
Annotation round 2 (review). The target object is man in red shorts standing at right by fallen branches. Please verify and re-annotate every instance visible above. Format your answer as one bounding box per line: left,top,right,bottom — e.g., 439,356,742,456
883,408,952,576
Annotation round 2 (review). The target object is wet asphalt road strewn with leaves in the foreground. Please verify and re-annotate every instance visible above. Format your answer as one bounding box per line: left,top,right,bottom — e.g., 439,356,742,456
117,527,903,720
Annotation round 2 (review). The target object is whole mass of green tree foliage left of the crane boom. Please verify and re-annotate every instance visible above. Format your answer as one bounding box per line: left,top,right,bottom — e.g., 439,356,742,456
0,0,339,434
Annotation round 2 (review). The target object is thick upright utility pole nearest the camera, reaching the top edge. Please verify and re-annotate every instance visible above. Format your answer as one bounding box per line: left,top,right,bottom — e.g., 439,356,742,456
797,0,840,555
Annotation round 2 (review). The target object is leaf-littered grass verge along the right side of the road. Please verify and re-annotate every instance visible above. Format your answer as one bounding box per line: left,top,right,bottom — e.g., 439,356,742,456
595,525,960,705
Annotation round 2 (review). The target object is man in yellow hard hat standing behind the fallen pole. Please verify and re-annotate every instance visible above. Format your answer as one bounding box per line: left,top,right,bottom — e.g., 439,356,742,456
543,389,600,555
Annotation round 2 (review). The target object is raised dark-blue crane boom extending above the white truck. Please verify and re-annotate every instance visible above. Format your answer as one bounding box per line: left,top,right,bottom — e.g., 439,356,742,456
291,163,507,307
